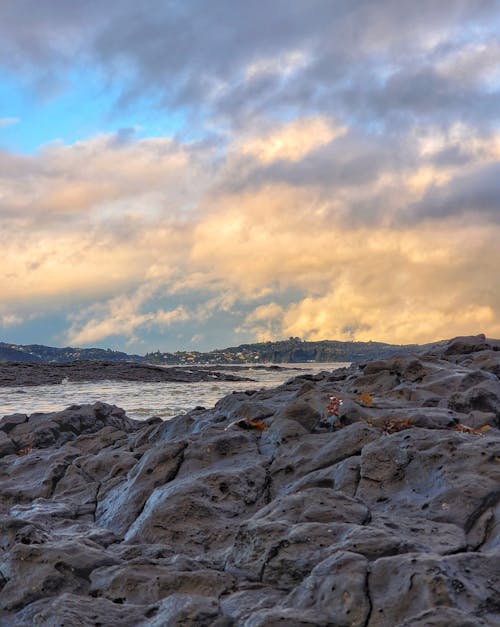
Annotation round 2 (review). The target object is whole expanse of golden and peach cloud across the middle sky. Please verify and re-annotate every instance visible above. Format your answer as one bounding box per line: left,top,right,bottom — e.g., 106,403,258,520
0,118,500,343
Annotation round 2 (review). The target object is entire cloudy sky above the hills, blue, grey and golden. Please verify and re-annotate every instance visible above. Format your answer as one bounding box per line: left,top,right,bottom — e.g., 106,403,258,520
0,0,500,354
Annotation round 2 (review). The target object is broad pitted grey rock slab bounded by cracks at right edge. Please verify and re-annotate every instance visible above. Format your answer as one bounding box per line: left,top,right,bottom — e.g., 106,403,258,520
356,429,500,531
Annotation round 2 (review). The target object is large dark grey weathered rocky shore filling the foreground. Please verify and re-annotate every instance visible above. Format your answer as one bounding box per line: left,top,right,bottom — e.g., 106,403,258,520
0,336,500,627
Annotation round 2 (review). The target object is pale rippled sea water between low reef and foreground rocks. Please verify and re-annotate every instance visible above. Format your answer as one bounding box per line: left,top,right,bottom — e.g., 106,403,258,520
0,363,349,420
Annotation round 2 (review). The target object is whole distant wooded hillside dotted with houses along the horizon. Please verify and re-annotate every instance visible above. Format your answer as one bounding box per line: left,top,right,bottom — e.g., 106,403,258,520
0,337,420,365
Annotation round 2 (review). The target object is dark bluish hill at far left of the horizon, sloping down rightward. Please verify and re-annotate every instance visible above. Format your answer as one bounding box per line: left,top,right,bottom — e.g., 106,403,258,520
0,342,145,363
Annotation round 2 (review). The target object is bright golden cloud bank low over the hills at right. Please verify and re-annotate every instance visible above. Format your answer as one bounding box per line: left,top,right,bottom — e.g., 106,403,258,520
190,184,500,342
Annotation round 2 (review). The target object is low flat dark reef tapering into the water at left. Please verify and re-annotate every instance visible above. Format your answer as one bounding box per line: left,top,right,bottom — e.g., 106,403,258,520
0,361,251,387
